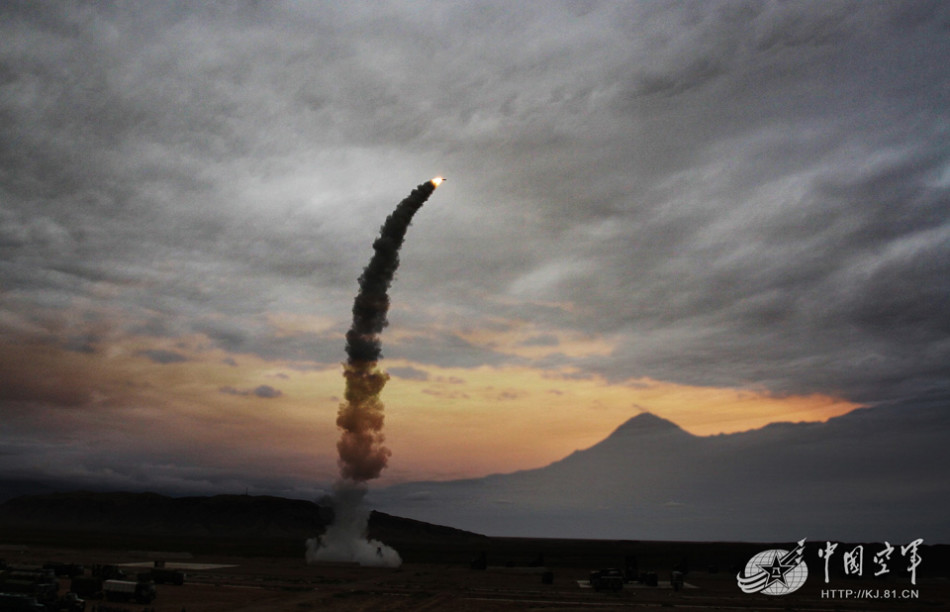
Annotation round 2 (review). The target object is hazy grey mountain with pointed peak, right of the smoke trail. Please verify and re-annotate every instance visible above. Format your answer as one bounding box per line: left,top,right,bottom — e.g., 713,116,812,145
371,407,950,543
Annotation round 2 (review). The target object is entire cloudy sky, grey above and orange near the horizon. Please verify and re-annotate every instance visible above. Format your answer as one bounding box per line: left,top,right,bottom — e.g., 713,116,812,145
0,1,950,492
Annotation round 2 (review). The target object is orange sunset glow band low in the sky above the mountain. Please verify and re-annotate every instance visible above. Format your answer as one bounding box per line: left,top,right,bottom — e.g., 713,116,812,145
0,328,857,483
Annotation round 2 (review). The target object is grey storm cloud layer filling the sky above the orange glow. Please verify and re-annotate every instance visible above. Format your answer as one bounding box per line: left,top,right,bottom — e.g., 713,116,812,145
0,1,950,420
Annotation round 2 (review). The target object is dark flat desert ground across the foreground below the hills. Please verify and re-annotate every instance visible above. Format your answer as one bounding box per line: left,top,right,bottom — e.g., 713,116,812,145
0,538,950,612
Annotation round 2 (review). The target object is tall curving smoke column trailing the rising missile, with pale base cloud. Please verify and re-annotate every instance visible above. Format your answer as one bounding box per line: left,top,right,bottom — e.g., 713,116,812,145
307,177,444,566
